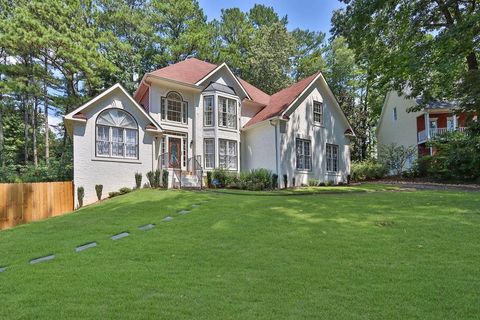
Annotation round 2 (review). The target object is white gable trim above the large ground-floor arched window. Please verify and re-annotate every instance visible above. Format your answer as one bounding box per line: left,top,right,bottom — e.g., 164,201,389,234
64,83,163,135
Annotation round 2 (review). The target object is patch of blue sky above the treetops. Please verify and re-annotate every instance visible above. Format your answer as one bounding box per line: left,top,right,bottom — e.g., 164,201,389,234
198,0,343,35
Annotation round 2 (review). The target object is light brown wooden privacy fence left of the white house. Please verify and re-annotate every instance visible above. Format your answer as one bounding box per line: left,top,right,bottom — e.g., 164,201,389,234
0,181,74,230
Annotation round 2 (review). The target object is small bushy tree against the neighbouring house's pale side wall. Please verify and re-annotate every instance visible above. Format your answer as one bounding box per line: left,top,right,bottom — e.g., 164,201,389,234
378,143,417,175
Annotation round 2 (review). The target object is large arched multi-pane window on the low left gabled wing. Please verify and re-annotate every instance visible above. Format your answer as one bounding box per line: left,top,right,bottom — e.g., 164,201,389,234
96,109,138,159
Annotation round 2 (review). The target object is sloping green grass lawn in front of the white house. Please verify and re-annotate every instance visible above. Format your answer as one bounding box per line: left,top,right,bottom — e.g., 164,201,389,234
0,185,480,319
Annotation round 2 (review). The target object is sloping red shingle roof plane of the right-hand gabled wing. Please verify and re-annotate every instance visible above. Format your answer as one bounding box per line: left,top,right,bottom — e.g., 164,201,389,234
245,72,320,127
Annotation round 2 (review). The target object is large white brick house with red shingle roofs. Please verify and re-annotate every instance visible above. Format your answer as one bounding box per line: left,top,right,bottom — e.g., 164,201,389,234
65,58,353,203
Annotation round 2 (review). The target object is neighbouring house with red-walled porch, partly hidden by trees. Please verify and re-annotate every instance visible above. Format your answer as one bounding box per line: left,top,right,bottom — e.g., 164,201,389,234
377,91,475,167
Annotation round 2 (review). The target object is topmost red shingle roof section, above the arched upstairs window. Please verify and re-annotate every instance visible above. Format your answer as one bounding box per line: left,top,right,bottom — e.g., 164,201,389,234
150,58,218,84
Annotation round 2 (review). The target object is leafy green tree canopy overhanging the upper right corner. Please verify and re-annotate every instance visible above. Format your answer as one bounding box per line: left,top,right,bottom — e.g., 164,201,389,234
332,0,480,112
